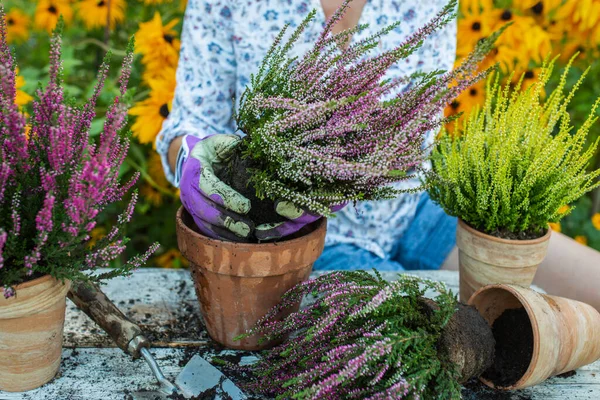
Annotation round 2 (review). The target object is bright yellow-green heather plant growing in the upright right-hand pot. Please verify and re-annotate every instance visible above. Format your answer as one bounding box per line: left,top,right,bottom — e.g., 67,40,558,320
427,60,600,239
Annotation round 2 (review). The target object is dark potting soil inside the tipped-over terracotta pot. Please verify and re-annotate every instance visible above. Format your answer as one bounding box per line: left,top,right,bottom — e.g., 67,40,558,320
483,308,533,386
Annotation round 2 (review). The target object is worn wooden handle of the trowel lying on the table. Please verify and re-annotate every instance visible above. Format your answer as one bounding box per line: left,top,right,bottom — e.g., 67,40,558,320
68,283,150,358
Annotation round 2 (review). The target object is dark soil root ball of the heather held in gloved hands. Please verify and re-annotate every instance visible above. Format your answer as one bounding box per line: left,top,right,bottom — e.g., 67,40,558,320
215,144,285,225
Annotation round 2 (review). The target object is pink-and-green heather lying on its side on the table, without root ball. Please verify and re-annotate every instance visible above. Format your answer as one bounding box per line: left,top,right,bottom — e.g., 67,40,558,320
232,271,462,400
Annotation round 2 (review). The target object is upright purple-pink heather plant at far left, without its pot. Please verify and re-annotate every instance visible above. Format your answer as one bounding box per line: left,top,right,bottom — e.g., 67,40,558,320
0,13,157,297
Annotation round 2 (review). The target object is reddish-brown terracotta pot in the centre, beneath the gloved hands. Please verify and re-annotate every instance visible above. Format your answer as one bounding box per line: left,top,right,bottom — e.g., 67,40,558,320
177,208,327,350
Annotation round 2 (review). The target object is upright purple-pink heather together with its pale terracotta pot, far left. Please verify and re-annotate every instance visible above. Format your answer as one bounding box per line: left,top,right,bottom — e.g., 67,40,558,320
0,14,157,391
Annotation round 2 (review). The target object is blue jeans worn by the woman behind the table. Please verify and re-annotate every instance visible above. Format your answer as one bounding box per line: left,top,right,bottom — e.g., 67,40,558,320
313,193,457,271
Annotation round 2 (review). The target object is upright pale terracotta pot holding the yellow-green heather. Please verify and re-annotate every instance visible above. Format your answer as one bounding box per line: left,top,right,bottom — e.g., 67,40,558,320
456,220,552,302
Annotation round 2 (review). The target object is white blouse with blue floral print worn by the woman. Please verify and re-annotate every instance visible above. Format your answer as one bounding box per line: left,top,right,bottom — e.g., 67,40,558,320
156,0,456,258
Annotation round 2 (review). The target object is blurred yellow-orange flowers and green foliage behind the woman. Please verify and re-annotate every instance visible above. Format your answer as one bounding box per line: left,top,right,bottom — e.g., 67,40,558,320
3,0,600,267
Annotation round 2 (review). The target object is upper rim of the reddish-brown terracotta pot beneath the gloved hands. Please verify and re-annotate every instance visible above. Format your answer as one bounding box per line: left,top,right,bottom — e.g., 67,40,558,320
175,206,327,251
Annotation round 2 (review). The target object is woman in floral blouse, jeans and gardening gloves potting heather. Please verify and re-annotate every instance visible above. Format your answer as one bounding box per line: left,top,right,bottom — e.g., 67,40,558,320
157,0,600,308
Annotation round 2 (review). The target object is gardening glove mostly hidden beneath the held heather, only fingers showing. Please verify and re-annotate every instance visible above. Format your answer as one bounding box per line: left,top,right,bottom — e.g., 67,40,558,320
254,201,346,240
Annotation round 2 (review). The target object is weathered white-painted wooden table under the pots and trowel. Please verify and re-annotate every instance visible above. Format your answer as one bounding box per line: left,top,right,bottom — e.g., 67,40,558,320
0,269,600,400
